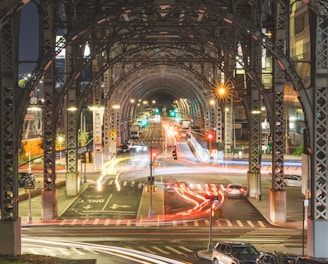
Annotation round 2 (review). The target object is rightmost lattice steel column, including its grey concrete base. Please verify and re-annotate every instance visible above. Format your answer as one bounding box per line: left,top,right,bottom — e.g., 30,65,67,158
308,11,328,258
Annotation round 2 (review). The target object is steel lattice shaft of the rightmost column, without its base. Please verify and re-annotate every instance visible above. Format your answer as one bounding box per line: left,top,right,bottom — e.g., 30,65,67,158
306,13,328,221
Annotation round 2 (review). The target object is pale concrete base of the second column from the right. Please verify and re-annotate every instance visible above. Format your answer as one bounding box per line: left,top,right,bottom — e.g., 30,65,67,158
270,189,287,224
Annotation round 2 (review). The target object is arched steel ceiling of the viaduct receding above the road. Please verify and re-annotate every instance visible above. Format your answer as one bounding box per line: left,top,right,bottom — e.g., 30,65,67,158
53,0,262,122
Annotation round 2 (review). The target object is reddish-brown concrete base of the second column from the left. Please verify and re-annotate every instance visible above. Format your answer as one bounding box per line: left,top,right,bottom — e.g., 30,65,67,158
41,190,58,220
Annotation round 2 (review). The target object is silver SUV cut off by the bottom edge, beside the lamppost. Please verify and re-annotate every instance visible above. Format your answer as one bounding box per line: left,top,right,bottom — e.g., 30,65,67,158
212,242,260,264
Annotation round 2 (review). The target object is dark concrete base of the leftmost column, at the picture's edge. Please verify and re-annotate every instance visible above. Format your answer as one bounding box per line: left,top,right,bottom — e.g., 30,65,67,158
0,218,21,256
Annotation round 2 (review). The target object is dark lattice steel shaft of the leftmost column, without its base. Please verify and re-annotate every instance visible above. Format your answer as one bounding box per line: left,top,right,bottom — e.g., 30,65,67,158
0,16,19,221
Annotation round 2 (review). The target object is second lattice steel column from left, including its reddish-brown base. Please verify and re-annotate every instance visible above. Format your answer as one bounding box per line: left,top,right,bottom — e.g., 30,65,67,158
40,2,58,220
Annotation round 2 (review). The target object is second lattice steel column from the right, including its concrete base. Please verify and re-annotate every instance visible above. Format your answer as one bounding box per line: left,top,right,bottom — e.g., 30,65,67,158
270,1,289,223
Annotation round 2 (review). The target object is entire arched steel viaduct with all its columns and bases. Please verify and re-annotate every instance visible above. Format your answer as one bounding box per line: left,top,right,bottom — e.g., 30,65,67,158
0,0,328,257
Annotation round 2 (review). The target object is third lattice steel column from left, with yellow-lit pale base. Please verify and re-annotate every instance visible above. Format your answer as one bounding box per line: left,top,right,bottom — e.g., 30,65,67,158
65,45,80,196
